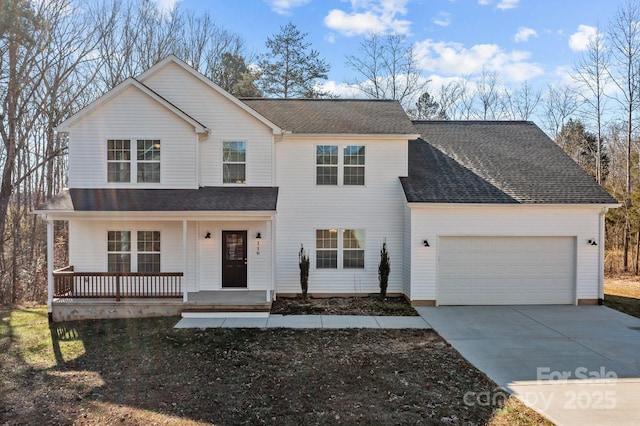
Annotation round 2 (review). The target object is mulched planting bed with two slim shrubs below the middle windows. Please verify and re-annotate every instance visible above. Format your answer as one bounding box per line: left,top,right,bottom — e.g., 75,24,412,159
271,296,418,316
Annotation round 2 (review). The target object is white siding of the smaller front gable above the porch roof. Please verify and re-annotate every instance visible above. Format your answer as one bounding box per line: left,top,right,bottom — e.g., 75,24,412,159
69,87,198,188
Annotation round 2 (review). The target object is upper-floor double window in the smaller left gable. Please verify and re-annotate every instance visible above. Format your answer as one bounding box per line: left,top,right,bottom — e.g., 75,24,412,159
107,139,160,183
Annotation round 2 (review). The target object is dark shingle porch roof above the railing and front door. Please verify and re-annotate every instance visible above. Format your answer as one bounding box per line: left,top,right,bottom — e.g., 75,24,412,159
36,187,278,212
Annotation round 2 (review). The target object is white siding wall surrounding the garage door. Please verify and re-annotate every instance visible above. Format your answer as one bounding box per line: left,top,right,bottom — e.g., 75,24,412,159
407,205,600,302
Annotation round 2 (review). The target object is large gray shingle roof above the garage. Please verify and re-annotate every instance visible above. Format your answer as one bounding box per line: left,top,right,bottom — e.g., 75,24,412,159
401,121,617,204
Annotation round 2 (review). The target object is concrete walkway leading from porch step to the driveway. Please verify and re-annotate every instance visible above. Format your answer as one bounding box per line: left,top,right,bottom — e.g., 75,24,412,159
175,315,431,329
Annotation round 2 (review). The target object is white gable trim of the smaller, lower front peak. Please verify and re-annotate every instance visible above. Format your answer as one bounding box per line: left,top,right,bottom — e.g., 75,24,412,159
56,78,209,134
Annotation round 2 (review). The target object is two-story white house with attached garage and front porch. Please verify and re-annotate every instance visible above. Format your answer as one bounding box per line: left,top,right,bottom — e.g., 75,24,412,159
36,56,617,319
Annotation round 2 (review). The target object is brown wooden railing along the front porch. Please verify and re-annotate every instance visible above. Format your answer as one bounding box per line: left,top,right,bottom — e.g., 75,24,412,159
53,266,183,301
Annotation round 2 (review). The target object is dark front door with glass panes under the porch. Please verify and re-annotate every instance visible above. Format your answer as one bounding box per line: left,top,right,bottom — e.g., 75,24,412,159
222,231,247,288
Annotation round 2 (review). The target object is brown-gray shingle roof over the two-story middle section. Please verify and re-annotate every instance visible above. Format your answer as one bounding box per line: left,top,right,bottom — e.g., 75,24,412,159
241,99,416,135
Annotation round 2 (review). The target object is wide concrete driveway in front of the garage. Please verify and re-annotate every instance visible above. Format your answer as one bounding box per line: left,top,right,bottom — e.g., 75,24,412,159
416,306,640,425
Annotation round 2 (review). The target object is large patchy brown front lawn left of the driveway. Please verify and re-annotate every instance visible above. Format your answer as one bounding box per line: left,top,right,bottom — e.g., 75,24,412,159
0,308,549,425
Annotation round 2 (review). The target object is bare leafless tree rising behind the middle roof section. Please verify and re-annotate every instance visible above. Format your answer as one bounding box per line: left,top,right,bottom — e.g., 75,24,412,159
346,34,429,110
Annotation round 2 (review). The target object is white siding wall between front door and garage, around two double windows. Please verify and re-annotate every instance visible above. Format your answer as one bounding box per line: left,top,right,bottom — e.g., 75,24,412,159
275,137,407,294
